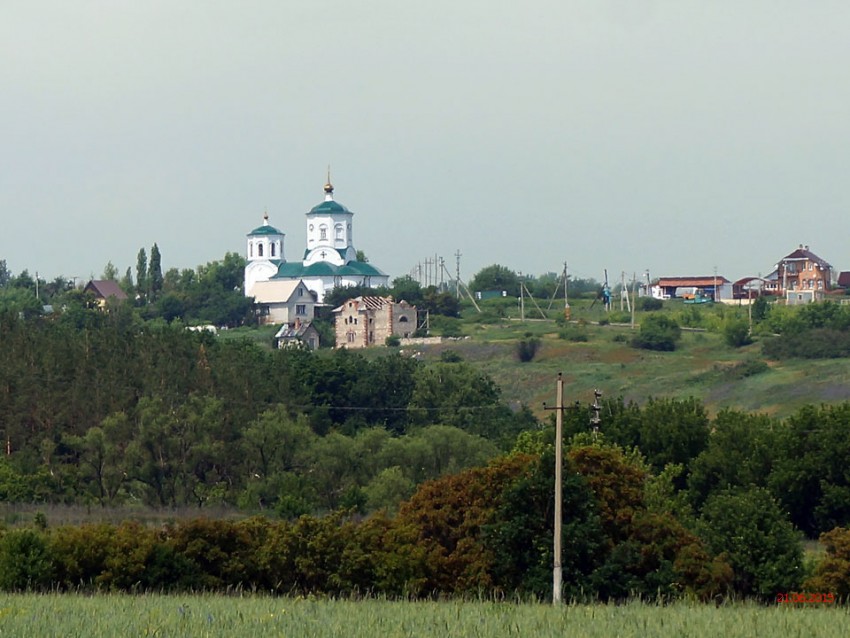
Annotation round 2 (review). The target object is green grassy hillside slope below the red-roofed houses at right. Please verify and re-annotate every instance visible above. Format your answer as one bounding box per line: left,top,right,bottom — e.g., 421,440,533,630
410,318,850,417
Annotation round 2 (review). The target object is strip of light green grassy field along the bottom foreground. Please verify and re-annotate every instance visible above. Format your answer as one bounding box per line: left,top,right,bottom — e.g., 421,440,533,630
0,594,850,638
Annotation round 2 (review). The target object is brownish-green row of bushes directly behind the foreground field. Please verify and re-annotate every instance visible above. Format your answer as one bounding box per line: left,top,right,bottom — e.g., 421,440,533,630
0,447,724,599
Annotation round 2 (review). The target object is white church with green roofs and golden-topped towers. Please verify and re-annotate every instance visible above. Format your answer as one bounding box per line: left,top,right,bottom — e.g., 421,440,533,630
245,180,389,304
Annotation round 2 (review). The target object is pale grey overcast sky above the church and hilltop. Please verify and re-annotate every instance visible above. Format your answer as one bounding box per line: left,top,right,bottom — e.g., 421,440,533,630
0,0,850,280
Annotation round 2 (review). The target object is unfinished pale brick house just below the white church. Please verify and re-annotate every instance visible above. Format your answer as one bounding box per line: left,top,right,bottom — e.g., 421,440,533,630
333,296,416,348
